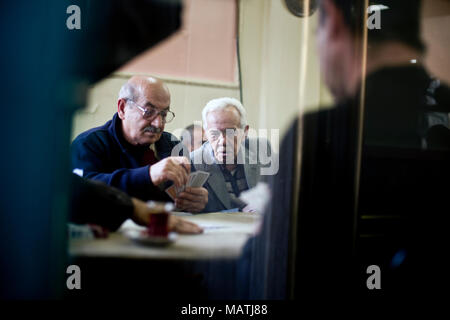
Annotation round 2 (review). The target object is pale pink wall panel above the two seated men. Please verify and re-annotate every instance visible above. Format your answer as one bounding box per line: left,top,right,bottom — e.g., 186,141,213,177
119,0,237,83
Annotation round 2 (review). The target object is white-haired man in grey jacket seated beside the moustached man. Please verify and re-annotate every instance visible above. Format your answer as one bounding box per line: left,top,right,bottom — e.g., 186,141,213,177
191,98,271,212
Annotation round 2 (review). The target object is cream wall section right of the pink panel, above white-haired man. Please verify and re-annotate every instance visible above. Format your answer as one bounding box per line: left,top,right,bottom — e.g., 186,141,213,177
239,0,331,133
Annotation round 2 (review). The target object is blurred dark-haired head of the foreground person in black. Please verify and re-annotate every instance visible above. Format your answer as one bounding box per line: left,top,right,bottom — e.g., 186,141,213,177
317,0,424,100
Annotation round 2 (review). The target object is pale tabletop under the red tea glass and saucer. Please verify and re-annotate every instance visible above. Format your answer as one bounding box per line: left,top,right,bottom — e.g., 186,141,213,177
69,212,262,260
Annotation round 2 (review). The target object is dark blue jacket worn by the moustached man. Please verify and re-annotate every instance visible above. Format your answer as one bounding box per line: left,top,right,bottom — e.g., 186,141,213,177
71,113,179,201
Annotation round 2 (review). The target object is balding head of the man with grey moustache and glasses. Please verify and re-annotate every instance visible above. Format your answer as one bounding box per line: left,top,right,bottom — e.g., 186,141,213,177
118,76,172,146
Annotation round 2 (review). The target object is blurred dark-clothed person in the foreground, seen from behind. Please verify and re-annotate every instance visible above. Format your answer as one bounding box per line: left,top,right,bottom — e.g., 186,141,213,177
240,0,450,301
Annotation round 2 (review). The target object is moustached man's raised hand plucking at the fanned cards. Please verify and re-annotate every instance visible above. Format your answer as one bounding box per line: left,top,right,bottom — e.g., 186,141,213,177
150,157,191,187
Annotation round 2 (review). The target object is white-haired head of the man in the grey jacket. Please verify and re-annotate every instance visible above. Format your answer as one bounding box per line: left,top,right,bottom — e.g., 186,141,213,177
202,98,248,164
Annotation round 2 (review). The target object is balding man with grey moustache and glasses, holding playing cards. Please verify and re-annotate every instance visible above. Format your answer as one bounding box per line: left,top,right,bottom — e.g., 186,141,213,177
72,76,208,212
